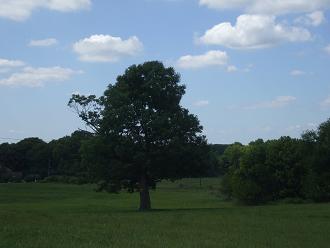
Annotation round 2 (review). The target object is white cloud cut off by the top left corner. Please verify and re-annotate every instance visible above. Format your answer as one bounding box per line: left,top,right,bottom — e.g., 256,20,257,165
0,0,91,21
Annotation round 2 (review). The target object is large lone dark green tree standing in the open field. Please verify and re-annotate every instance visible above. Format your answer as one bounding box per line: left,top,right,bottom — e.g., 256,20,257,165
69,61,208,210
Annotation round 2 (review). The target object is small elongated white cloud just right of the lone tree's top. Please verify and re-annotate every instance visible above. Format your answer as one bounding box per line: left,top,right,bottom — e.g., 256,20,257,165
177,51,229,69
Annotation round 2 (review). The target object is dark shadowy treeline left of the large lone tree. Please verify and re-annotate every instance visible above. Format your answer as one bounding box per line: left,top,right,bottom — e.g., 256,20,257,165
0,131,93,183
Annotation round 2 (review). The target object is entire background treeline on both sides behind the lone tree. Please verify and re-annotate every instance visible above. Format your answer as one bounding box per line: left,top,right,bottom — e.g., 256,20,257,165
0,119,330,204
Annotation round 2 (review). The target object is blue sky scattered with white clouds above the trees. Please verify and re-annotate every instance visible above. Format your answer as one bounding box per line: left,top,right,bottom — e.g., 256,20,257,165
0,0,330,144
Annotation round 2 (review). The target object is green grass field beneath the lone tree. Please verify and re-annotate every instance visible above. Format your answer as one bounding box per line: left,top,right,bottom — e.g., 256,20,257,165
0,179,330,248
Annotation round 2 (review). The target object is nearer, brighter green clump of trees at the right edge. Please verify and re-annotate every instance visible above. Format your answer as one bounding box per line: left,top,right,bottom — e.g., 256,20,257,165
220,119,330,204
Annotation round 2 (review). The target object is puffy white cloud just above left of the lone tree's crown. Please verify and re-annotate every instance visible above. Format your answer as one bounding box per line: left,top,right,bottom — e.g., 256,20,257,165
73,34,143,62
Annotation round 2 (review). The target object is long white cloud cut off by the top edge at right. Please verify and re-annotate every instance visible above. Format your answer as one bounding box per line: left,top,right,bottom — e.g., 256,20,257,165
199,0,330,15
